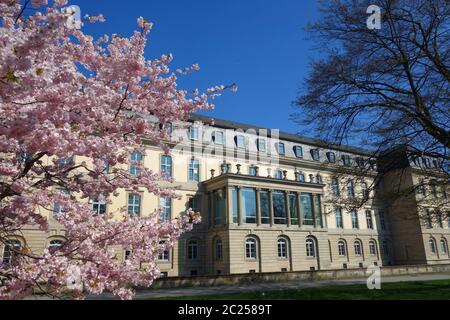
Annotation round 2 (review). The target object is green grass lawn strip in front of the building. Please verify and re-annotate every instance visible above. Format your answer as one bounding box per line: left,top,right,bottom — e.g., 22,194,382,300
143,280,450,300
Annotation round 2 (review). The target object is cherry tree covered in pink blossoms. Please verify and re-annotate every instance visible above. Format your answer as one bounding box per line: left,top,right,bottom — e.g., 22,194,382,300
0,0,224,299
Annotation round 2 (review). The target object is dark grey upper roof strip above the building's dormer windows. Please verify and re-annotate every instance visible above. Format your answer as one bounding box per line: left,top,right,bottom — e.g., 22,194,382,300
190,113,373,157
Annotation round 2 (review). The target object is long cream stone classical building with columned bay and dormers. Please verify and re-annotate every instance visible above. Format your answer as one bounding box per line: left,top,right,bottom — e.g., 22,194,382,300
3,115,450,276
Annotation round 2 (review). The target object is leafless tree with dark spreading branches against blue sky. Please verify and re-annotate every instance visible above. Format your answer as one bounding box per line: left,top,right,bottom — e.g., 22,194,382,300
293,0,450,219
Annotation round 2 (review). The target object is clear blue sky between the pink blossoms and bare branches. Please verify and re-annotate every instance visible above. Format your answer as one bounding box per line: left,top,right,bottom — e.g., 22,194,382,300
70,0,318,135
